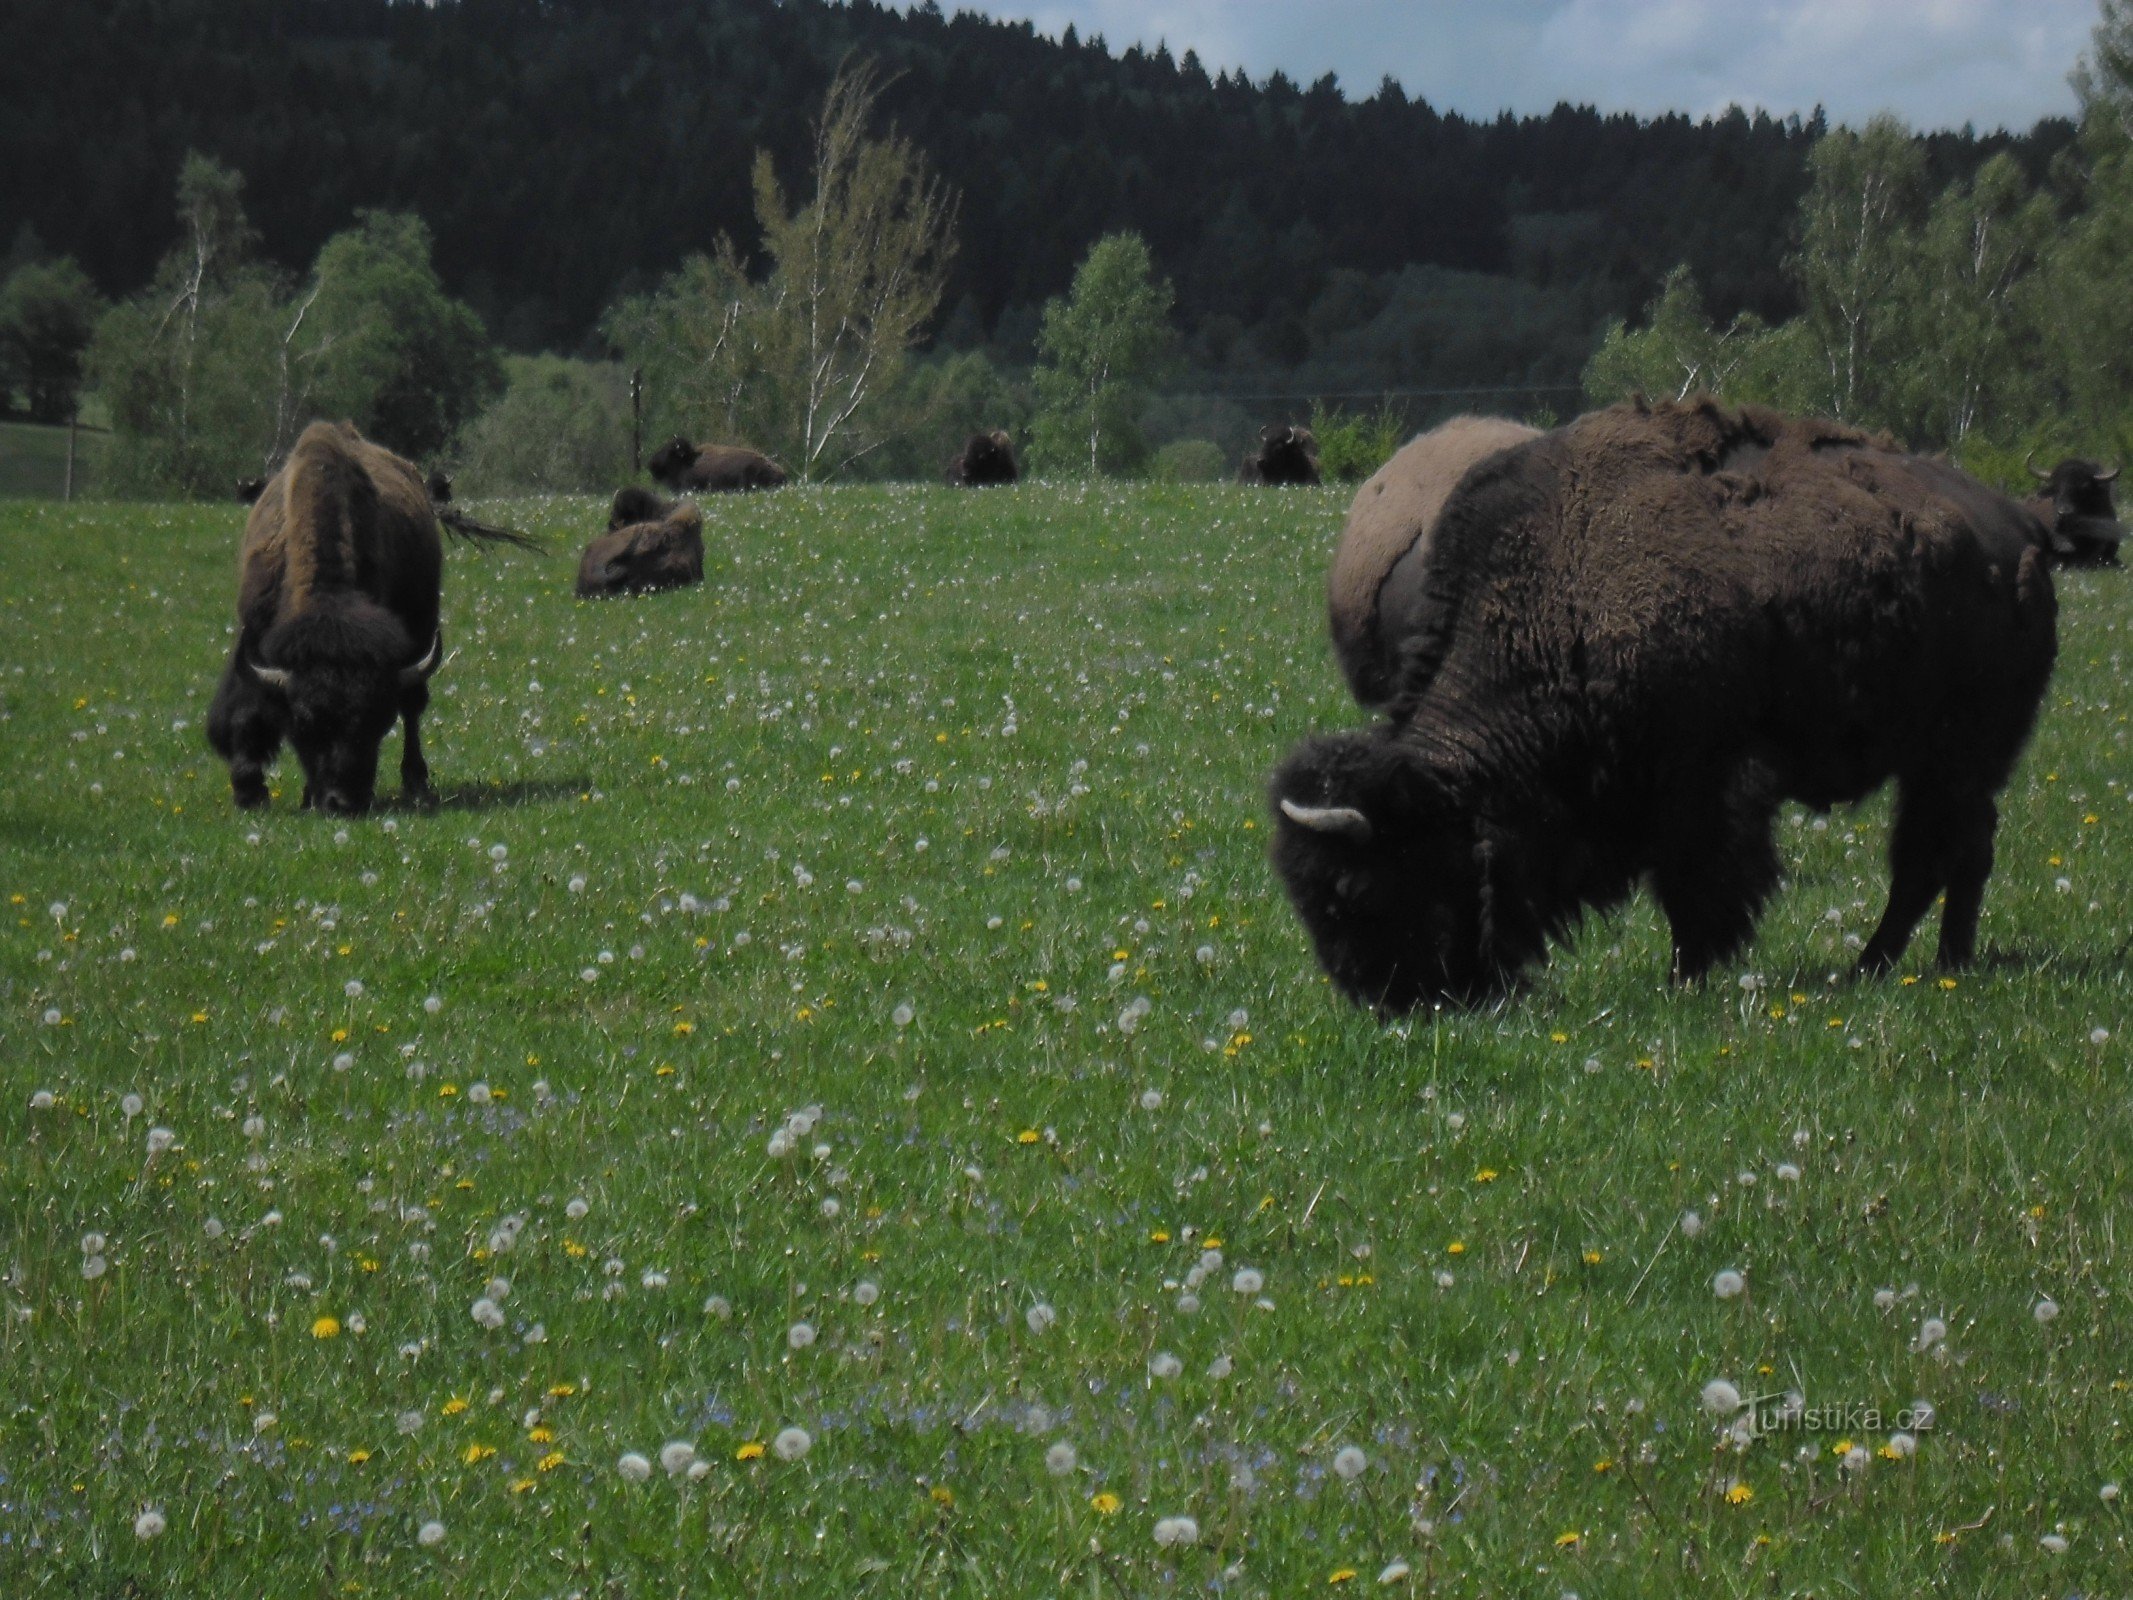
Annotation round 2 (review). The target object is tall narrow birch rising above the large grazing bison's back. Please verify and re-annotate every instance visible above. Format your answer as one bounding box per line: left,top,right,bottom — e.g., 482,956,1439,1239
1792,115,1928,422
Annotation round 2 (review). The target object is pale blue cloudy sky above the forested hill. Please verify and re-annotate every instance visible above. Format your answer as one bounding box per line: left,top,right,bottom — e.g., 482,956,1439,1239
959,0,2097,130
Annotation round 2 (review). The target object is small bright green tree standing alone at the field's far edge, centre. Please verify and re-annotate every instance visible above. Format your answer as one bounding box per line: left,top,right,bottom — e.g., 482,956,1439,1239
1030,233,1175,478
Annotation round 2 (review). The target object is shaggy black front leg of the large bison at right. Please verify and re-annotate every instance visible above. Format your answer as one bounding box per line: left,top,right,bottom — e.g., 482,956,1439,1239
1651,764,1779,983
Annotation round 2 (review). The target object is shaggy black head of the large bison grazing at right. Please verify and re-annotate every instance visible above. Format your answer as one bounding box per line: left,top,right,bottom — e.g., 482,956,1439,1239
1271,730,1546,1013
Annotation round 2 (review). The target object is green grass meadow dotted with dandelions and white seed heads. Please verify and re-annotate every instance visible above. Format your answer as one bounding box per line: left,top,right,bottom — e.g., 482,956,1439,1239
0,486,2133,1600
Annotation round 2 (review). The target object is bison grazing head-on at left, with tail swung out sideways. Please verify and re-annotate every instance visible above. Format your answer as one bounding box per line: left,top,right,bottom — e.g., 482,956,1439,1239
207,422,527,811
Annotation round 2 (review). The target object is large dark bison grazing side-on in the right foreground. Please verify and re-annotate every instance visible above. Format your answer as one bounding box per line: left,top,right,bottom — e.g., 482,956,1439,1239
1271,401,2056,1011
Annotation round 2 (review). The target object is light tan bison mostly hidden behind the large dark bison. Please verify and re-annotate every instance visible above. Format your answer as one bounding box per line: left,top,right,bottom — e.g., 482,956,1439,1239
1327,416,1540,708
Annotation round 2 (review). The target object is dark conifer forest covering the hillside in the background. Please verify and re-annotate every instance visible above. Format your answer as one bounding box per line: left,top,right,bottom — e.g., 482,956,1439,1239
0,0,2092,492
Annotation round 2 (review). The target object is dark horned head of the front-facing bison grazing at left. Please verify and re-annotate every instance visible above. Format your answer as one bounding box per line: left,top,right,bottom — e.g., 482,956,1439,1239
243,599,444,813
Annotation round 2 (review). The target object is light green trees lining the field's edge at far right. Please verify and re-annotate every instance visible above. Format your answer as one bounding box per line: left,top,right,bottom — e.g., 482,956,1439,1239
1585,83,2133,482
